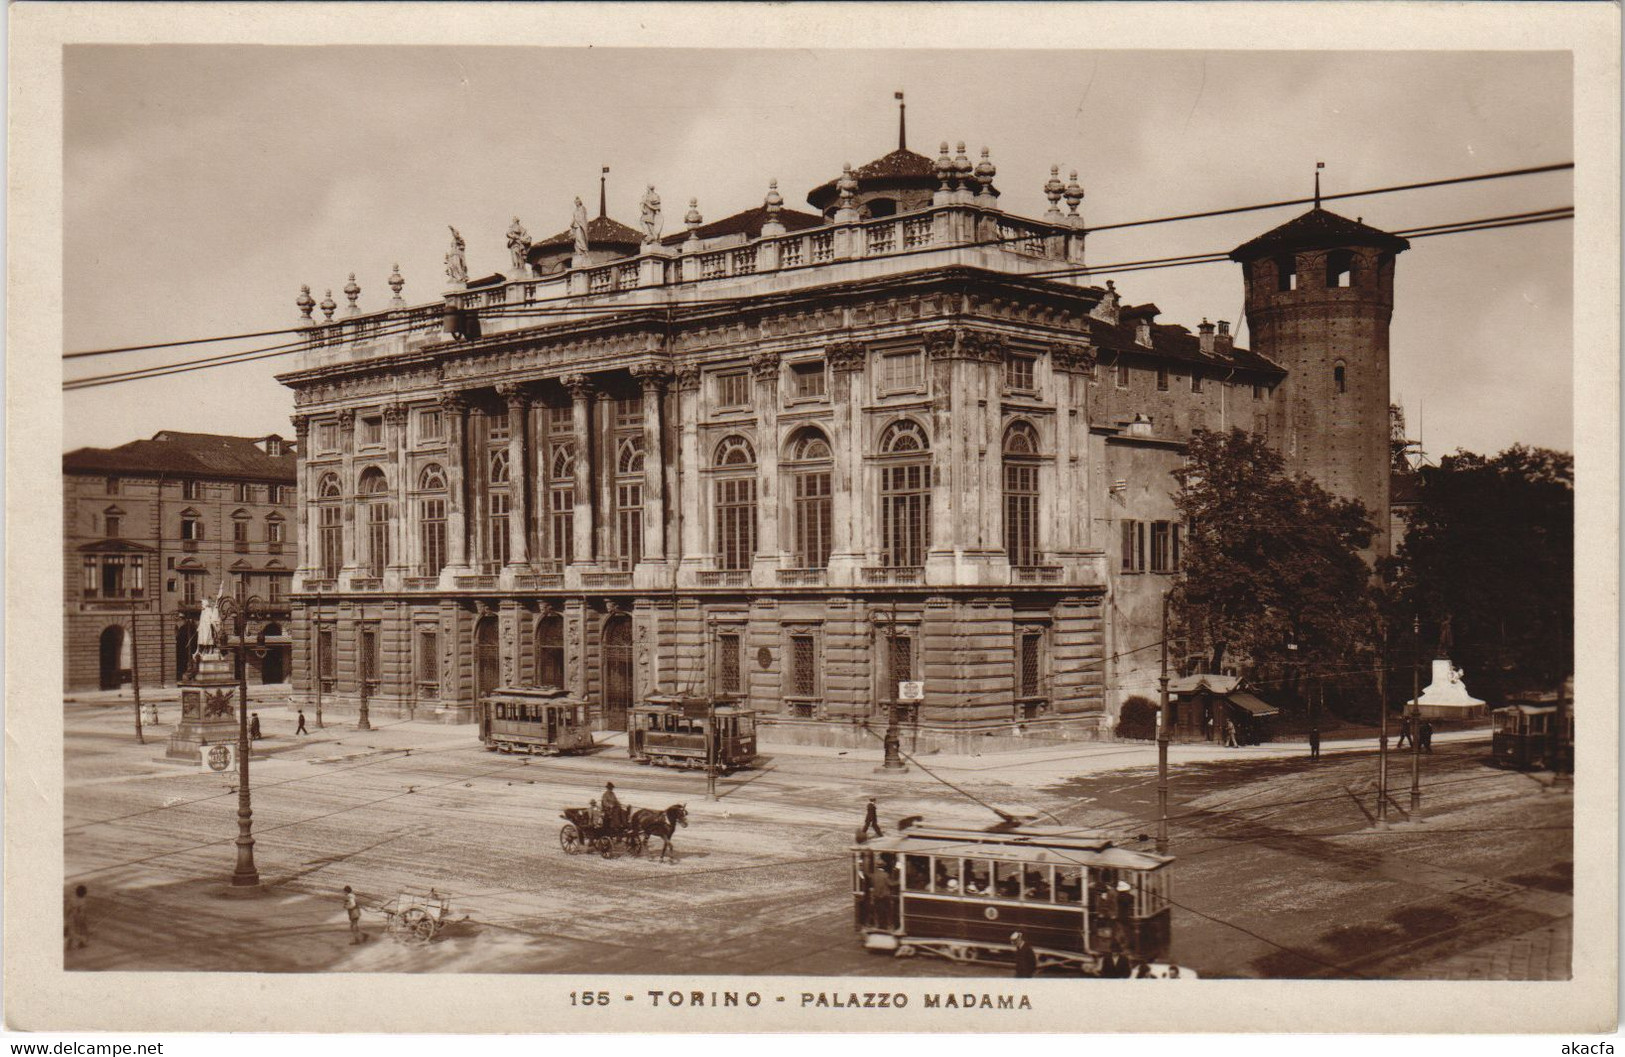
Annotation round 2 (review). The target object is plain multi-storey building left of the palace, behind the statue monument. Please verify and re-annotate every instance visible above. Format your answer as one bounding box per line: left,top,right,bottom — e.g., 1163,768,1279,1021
62,429,299,691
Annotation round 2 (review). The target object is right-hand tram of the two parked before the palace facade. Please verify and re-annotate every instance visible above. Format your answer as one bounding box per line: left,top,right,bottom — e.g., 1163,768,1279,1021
626,694,756,774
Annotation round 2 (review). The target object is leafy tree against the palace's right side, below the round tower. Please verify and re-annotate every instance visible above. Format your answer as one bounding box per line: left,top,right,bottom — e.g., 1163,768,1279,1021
1172,429,1376,691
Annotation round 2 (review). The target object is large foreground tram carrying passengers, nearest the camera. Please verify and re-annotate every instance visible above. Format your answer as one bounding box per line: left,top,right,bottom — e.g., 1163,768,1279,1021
852,826,1173,974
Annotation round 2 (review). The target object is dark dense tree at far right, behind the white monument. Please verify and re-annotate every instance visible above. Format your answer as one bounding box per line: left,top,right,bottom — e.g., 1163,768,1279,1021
1391,444,1575,698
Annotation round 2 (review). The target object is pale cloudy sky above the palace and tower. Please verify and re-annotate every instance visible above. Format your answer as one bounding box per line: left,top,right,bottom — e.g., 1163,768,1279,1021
63,46,1573,459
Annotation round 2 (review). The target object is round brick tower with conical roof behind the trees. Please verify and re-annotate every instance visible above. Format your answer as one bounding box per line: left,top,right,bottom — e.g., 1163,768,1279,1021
1230,207,1411,556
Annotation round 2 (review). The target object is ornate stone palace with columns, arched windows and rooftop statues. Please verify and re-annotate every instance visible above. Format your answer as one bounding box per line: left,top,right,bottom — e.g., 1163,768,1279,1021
281,135,1394,740
